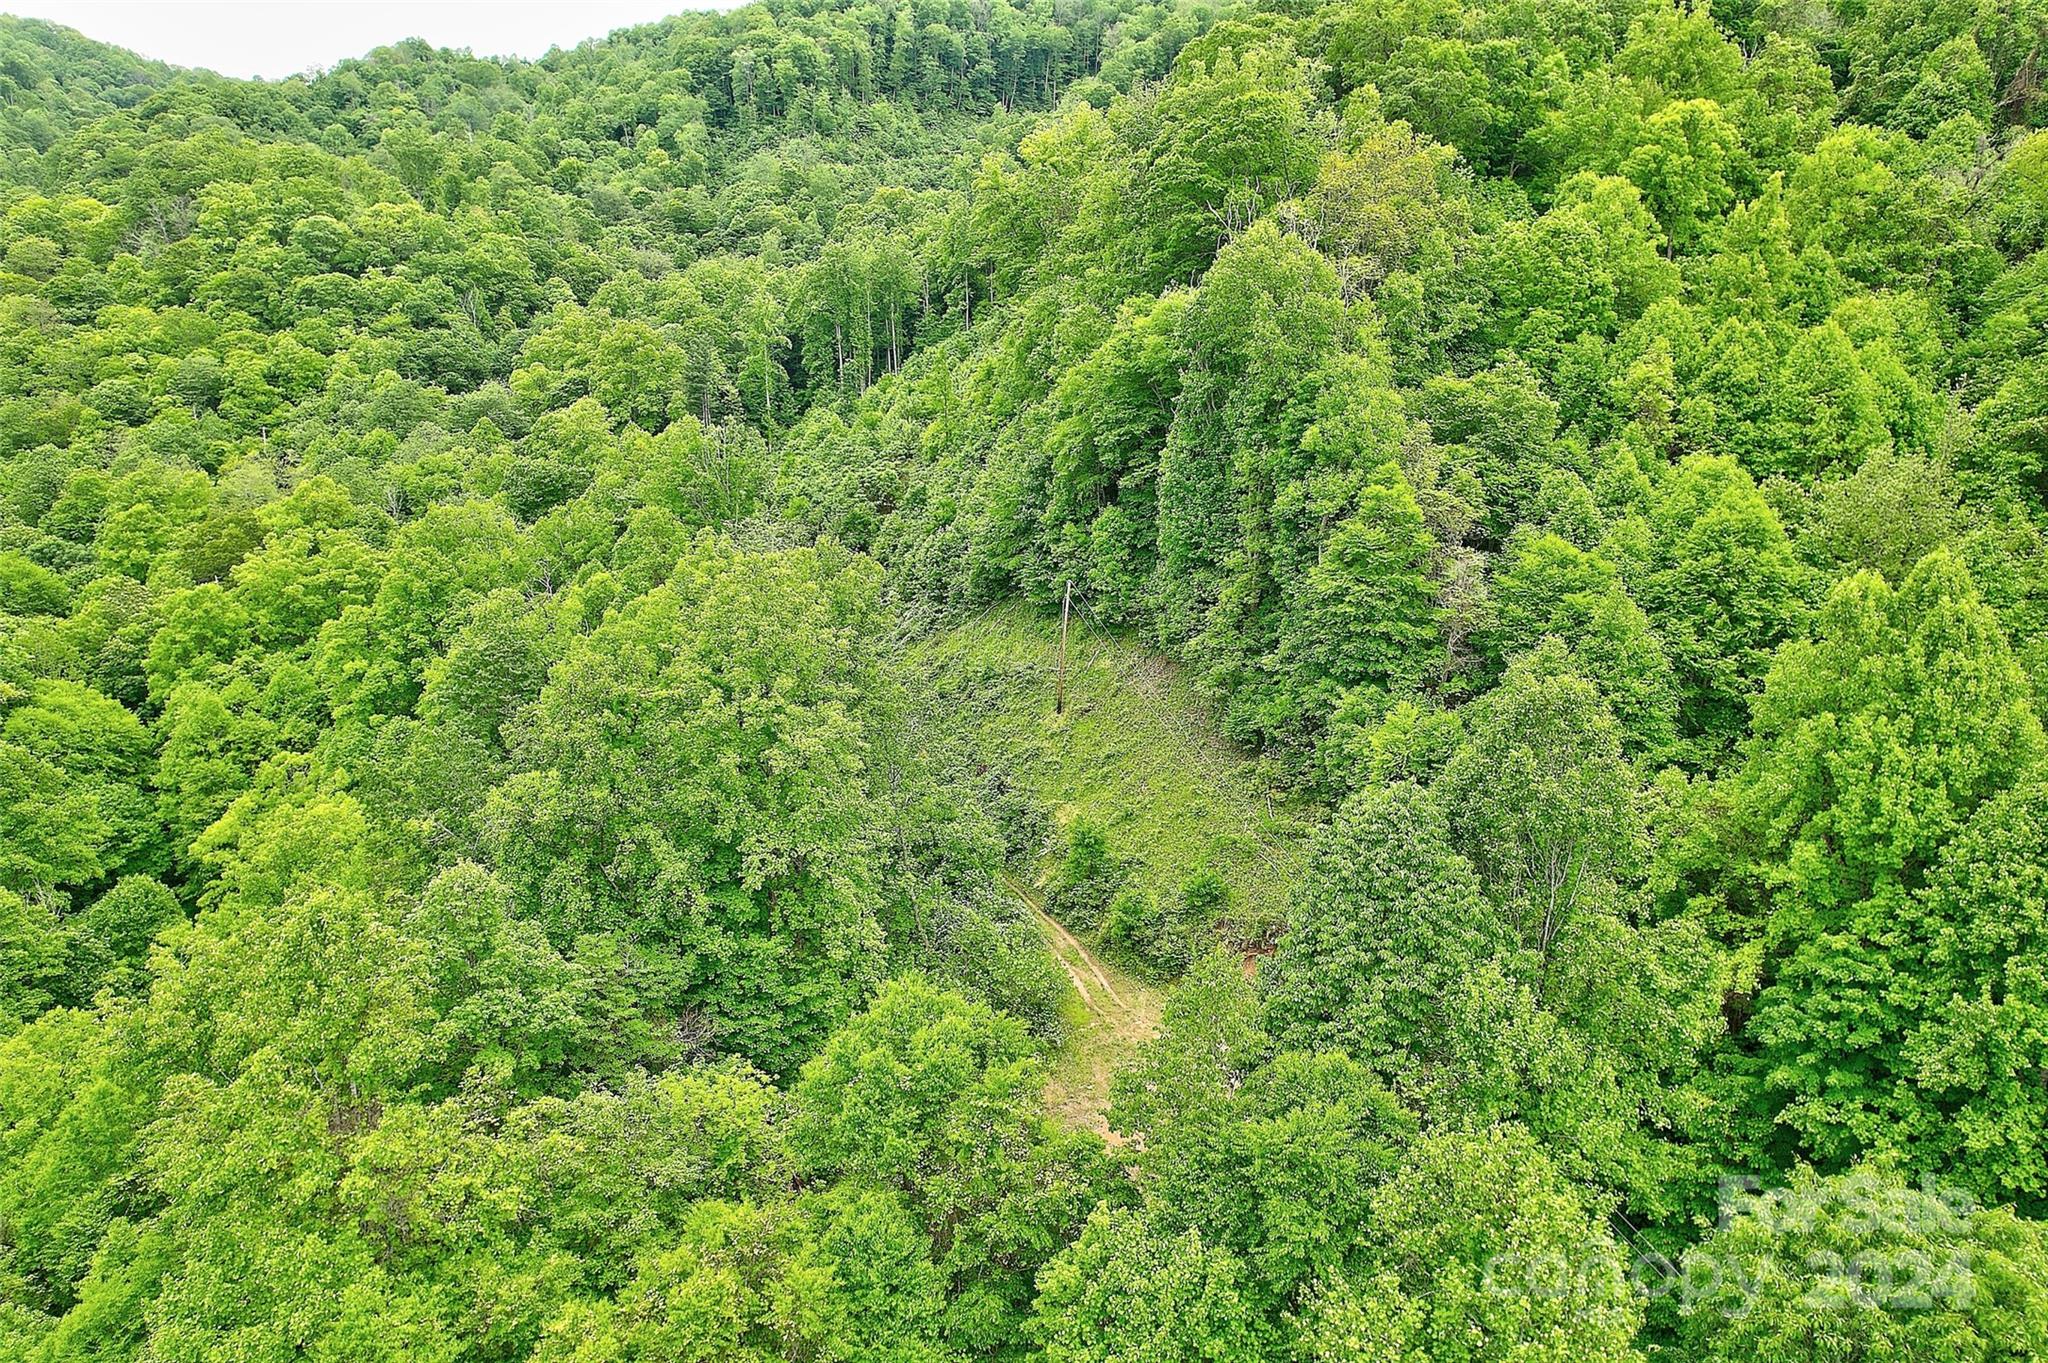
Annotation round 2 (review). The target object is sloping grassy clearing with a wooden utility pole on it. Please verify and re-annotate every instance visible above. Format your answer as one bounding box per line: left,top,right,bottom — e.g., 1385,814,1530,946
918,608,1309,937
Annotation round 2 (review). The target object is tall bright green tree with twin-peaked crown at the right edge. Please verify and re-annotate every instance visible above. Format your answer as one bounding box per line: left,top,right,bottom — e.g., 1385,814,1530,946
1733,551,2048,1193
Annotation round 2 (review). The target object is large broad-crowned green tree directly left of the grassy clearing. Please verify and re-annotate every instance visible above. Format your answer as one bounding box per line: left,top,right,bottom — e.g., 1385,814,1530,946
483,540,887,1068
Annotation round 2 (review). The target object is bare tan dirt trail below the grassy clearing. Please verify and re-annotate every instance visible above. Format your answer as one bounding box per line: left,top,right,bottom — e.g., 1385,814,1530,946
1004,876,1159,1144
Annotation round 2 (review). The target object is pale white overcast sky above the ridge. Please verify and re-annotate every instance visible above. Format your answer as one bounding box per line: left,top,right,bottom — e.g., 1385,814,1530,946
0,0,737,78
